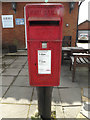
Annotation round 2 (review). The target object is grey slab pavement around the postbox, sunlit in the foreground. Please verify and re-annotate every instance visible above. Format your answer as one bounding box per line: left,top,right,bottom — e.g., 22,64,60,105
0,50,88,120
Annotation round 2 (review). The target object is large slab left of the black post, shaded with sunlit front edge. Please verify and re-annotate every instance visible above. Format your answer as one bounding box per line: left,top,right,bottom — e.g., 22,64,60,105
1,86,33,104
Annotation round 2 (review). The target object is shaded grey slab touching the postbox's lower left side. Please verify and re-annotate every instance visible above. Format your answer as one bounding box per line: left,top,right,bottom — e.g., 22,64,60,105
13,76,30,86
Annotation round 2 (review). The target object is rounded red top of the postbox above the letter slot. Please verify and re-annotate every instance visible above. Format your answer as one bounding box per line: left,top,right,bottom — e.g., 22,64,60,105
25,3,64,21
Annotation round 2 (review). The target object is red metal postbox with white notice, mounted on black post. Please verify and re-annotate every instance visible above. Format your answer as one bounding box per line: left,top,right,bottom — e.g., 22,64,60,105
25,3,63,86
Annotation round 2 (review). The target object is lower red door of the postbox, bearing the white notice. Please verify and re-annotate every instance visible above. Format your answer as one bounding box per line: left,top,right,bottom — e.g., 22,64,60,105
28,41,61,86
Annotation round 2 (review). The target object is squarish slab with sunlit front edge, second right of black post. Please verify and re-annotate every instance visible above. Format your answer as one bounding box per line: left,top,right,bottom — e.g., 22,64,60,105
59,88,81,106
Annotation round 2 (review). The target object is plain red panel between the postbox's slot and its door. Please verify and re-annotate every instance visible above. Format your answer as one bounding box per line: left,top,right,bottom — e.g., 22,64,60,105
29,26,60,40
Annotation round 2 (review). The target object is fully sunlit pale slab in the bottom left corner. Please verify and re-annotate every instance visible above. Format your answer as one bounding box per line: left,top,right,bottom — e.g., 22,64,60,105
0,104,29,119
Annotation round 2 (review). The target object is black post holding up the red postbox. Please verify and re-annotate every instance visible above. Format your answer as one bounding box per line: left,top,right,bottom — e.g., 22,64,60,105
37,87,53,120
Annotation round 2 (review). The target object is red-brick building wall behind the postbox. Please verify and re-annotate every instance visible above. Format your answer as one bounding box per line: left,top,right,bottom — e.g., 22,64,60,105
2,0,79,49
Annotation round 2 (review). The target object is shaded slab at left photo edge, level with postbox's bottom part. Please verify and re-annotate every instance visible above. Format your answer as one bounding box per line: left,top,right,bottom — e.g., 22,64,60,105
0,76,14,86
